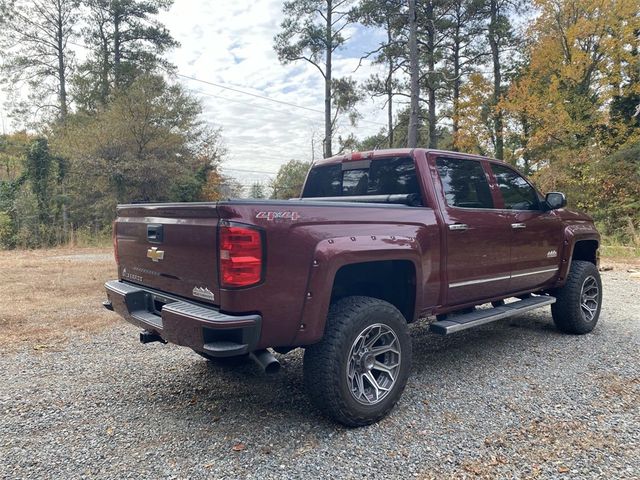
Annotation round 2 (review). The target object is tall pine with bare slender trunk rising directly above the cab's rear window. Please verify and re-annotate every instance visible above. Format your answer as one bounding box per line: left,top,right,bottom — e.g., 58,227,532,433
274,0,358,157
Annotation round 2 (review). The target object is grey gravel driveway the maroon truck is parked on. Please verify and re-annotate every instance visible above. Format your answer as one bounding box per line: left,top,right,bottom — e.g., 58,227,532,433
0,271,640,479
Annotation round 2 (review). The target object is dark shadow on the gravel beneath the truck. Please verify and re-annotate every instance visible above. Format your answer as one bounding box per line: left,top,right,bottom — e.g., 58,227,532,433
112,316,566,435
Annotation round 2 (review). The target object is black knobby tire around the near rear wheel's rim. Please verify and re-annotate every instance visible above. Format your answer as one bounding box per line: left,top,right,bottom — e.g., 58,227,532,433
303,296,411,427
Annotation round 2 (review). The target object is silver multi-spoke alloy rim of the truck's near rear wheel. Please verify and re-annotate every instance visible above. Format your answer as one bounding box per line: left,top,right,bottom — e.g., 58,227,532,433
347,323,402,405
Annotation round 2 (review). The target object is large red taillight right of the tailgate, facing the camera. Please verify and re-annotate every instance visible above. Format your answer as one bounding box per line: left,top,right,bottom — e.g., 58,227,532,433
219,225,262,288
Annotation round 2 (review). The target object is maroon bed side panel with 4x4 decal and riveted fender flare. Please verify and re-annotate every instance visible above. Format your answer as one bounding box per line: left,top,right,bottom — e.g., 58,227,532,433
218,201,440,347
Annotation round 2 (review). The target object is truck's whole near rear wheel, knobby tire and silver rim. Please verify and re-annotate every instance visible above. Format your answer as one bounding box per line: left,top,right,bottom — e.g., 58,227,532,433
303,297,411,427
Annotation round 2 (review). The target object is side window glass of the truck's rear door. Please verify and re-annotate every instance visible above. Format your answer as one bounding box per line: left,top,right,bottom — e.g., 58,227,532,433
436,158,494,208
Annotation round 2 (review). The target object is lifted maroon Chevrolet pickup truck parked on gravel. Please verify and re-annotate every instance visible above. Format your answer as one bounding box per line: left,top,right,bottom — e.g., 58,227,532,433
105,149,602,426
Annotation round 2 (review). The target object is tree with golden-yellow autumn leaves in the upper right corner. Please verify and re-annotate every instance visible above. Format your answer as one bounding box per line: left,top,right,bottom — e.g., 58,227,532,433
501,0,640,161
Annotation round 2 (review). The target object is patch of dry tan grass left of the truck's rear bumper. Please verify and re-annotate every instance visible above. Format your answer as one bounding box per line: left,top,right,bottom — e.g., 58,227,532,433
0,248,118,350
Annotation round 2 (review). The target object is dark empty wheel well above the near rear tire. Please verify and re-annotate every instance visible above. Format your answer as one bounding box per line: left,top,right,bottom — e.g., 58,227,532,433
331,260,416,322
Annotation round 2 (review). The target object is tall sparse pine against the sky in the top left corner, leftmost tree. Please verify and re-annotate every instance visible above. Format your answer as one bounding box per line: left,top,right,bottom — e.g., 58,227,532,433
0,0,79,121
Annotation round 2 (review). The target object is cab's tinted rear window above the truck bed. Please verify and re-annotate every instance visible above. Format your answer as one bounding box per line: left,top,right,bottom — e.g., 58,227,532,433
302,157,420,197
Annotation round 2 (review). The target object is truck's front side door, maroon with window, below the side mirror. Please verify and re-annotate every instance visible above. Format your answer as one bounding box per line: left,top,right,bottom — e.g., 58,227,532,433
489,163,564,292
